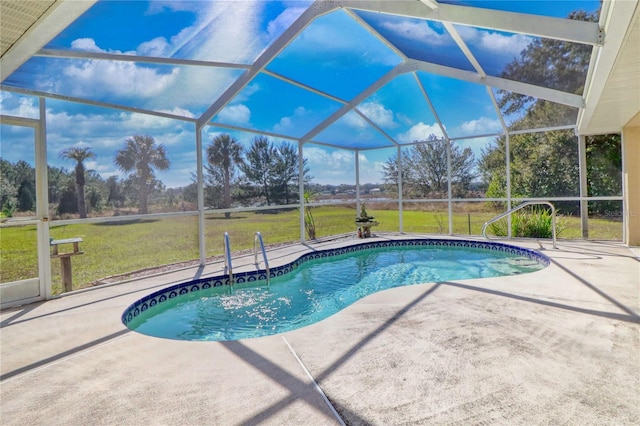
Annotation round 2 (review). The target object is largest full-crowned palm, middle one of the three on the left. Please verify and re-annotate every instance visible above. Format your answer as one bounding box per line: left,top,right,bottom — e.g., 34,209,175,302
115,135,170,214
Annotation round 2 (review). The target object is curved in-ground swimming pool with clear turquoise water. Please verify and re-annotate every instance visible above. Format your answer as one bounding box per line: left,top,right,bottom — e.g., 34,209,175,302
122,239,549,341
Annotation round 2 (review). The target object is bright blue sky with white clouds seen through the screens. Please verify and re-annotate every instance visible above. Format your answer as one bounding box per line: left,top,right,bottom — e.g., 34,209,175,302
0,0,599,187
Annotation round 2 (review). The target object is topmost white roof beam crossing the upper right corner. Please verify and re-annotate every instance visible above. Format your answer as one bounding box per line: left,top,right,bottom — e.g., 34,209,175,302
339,0,601,45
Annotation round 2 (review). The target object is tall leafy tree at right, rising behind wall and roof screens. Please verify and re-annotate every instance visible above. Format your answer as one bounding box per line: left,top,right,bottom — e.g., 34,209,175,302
479,11,619,213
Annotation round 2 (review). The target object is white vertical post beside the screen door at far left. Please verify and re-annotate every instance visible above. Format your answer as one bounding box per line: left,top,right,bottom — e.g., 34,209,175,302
34,97,53,299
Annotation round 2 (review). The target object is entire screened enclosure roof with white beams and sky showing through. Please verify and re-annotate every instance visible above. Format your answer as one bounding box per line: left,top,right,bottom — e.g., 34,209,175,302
2,0,612,153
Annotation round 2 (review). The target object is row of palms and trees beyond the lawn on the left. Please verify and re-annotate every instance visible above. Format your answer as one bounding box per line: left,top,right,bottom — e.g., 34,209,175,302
0,134,311,218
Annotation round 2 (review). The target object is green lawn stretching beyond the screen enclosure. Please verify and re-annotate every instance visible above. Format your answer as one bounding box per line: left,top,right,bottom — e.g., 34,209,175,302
0,203,622,294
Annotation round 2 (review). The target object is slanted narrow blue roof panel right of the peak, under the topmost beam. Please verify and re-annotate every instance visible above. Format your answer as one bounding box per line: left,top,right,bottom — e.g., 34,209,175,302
356,11,473,71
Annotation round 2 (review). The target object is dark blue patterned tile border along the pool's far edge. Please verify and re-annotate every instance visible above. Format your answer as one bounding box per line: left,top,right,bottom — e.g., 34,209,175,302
121,239,551,325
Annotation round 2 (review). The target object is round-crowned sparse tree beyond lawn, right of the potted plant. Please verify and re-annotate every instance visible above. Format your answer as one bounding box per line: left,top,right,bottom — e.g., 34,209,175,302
383,135,475,197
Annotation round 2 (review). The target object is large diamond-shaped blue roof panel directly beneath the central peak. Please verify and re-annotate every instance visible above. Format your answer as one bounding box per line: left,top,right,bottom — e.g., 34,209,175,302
267,10,402,101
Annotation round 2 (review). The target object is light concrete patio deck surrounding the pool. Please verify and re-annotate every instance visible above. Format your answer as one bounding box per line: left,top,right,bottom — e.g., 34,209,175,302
0,236,640,425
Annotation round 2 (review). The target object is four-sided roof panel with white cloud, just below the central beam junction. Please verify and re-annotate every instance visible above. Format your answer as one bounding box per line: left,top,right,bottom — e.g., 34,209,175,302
358,73,443,144
